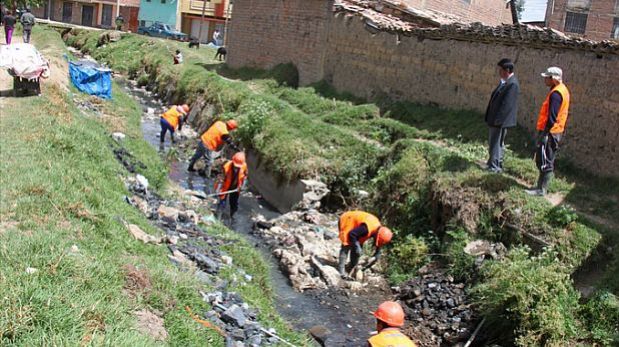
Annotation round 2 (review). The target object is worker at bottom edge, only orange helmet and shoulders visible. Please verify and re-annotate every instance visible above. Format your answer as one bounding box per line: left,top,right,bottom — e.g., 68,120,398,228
368,301,417,347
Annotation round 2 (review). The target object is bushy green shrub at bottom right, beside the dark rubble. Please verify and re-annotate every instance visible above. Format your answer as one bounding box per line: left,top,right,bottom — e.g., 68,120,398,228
473,246,579,346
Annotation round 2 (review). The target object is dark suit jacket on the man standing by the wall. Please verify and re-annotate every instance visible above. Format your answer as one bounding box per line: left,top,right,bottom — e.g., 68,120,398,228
485,75,520,128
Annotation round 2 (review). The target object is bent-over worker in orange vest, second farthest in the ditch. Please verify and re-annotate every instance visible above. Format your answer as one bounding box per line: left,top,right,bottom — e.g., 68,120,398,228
188,119,239,171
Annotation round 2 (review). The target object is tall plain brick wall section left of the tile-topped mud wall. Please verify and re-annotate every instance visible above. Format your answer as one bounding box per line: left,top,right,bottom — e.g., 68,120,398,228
227,0,332,84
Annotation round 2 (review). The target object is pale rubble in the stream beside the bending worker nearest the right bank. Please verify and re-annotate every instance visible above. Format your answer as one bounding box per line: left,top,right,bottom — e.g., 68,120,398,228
253,180,386,292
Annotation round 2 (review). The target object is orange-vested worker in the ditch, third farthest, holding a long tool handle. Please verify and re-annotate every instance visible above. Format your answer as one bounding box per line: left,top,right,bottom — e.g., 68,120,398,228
215,152,247,219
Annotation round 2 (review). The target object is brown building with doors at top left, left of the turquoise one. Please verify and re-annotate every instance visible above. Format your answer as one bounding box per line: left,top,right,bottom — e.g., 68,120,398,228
32,0,140,32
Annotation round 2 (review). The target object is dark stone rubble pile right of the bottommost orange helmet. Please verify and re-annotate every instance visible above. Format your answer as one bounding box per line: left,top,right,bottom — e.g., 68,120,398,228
398,271,475,346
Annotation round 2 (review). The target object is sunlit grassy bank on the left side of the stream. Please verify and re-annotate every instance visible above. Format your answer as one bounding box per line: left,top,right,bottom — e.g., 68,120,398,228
0,27,304,346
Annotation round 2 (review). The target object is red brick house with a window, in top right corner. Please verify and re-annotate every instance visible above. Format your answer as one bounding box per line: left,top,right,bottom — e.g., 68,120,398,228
546,0,619,40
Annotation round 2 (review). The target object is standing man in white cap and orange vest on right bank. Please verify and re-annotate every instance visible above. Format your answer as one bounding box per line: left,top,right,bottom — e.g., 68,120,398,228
526,67,570,196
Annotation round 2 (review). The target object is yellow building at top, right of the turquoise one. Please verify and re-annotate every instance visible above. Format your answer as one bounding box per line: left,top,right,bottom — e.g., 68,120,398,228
180,0,232,43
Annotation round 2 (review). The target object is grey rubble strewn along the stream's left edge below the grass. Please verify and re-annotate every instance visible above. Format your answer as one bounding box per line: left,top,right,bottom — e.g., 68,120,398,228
117,162,280,347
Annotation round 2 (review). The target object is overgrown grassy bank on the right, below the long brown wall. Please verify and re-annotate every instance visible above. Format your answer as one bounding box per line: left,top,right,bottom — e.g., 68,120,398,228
68,28,619,345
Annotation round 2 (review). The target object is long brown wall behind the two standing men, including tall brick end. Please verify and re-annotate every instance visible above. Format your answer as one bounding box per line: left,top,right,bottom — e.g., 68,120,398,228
228,0,619,176
